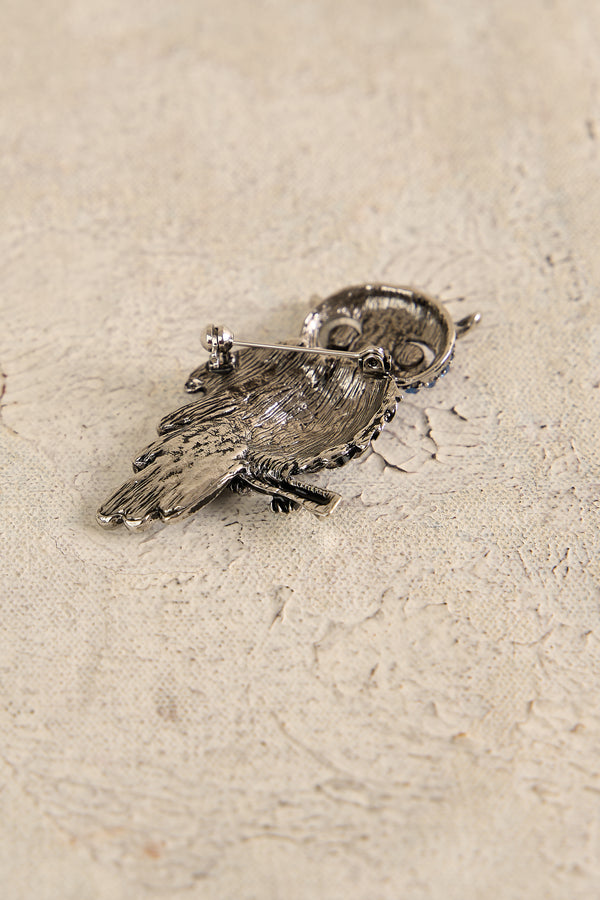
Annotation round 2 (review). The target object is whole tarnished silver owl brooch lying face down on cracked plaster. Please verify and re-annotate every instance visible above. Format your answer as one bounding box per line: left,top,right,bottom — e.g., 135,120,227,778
97,285,479,529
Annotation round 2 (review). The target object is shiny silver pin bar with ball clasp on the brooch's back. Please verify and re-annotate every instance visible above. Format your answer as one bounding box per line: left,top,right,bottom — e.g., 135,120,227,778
202,325,391,377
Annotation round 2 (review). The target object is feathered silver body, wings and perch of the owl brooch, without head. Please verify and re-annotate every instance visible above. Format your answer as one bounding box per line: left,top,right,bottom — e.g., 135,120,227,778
98,349,398,529
